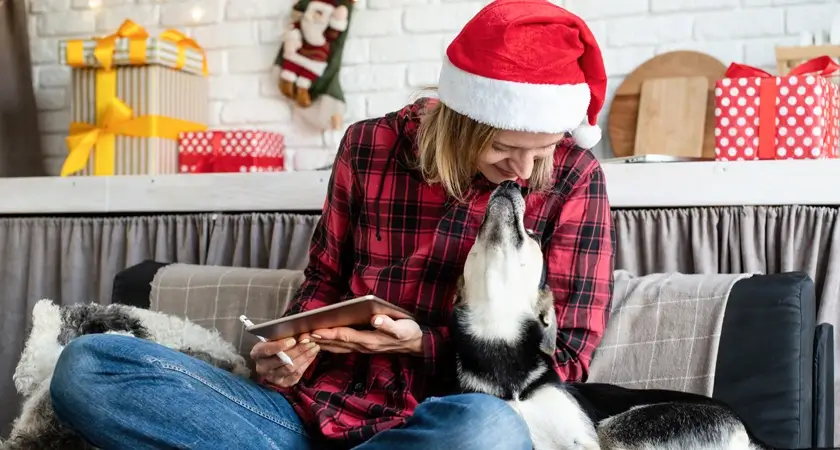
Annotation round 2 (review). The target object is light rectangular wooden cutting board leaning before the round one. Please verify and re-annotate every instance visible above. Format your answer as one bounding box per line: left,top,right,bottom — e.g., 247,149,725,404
635,76,708,158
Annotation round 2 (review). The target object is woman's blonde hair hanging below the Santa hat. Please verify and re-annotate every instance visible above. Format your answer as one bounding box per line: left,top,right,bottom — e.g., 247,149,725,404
417,102,554,201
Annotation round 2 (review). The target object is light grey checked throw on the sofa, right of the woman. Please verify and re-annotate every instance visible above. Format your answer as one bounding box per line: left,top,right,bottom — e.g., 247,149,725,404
589,270,749,395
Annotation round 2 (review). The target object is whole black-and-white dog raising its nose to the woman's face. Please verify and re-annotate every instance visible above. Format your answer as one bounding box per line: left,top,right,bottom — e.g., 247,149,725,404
451,182,808,450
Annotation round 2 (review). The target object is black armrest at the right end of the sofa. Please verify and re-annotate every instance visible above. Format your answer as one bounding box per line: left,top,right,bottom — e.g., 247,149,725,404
713,272,817,448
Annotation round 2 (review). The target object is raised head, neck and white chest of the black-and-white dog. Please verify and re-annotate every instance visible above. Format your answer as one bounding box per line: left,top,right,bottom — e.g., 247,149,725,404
450,182,599,450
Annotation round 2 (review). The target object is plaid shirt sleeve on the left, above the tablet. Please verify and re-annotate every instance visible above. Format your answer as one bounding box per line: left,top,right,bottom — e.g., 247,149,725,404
286,126,358,315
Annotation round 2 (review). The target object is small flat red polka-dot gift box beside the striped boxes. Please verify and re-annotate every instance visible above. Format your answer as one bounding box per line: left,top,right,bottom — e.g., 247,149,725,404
178,130,286,173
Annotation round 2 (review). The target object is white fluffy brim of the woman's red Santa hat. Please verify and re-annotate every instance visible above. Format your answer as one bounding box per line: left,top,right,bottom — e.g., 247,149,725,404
438,57,591,133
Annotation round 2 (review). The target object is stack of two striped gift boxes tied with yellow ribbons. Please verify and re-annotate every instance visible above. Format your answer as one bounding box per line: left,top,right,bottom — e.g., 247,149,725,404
59,20,209,176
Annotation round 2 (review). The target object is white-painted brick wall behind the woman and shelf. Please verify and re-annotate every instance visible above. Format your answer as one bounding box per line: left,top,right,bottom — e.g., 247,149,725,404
30,0,840,173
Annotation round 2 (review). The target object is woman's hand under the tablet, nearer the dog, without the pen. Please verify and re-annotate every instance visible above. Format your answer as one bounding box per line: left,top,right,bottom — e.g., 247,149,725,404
311,316,423,356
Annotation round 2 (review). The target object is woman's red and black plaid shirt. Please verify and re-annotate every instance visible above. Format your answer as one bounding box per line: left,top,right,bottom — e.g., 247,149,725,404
270,100,615,445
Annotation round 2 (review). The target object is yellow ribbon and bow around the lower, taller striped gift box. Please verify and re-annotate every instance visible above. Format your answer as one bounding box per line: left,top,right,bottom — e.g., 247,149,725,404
61,98,207,176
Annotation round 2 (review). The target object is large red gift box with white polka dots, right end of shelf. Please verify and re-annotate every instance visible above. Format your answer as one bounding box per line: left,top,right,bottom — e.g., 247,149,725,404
715,56,840,161
